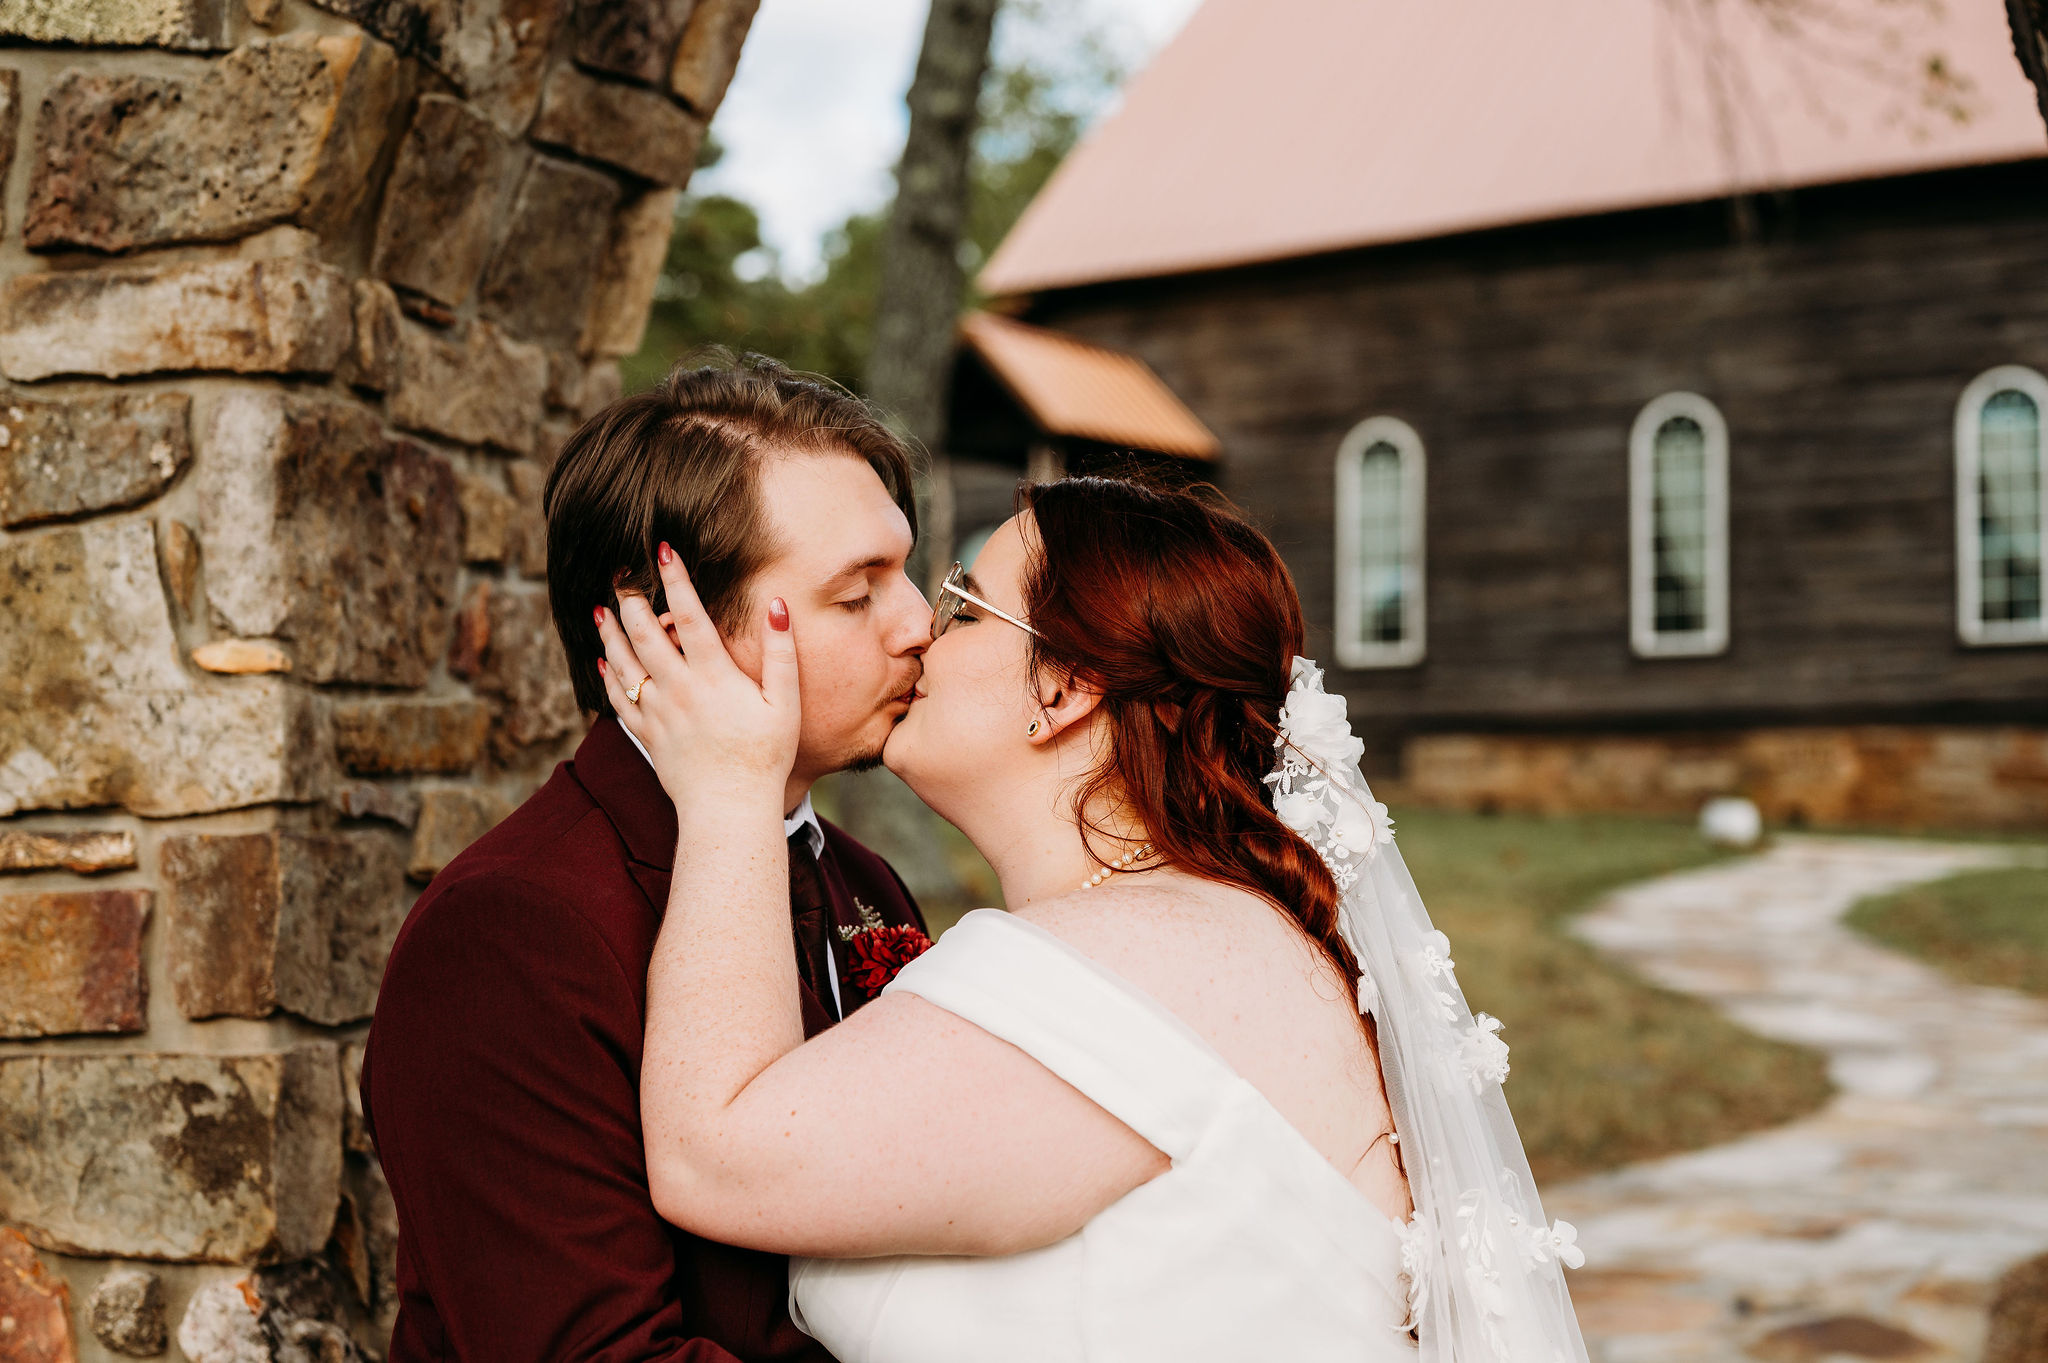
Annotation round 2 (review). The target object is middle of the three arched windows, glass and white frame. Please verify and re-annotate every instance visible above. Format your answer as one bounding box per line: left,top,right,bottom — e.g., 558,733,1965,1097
1628,393,1729,657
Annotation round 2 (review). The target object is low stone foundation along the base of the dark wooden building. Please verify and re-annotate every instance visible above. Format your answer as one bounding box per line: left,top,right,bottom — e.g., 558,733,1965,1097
1399,724,2048,833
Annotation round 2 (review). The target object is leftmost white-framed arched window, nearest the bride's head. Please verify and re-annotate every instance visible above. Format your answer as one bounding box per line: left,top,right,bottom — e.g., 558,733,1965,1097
1337,417,1425,667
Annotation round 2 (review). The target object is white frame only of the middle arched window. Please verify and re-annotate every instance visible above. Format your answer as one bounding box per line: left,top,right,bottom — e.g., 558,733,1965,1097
1628,393,1729,657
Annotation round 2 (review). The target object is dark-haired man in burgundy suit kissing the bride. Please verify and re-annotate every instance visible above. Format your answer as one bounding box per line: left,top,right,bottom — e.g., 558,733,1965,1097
362,362,932,1363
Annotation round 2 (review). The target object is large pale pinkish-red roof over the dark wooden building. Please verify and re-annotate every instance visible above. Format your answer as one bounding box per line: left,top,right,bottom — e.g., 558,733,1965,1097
981,0,2048,295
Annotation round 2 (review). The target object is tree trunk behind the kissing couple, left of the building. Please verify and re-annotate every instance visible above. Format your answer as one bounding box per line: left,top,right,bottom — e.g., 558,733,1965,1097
836,0,999,907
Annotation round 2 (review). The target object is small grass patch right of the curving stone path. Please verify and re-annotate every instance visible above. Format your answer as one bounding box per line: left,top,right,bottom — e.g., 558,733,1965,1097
1849,866,2048,997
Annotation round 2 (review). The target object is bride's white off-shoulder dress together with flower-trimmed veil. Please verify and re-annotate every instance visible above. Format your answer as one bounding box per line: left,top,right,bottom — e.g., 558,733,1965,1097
791,657,1587,1363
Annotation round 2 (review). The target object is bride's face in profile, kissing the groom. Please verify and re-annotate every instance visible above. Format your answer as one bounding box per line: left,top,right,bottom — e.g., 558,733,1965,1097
883,516,1038,817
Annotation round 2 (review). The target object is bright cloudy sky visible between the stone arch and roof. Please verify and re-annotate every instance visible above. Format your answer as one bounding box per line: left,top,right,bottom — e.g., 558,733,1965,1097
690,0,1198,276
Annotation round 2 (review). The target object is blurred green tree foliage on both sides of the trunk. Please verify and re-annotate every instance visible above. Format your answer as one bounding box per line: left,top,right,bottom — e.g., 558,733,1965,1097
625,0,1124,391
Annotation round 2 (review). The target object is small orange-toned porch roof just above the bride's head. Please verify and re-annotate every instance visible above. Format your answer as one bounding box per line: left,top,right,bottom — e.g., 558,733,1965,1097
961,313,1223,458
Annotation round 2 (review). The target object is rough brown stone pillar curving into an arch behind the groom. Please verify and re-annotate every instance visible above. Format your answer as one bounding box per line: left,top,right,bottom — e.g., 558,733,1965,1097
0,0,758,1363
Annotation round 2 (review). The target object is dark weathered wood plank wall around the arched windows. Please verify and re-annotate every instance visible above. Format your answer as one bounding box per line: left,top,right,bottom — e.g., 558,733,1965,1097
1032,166,2048,757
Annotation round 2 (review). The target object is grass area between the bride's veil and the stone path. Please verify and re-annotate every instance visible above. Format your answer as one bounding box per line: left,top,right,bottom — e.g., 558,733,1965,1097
1395,808,1829,1179
